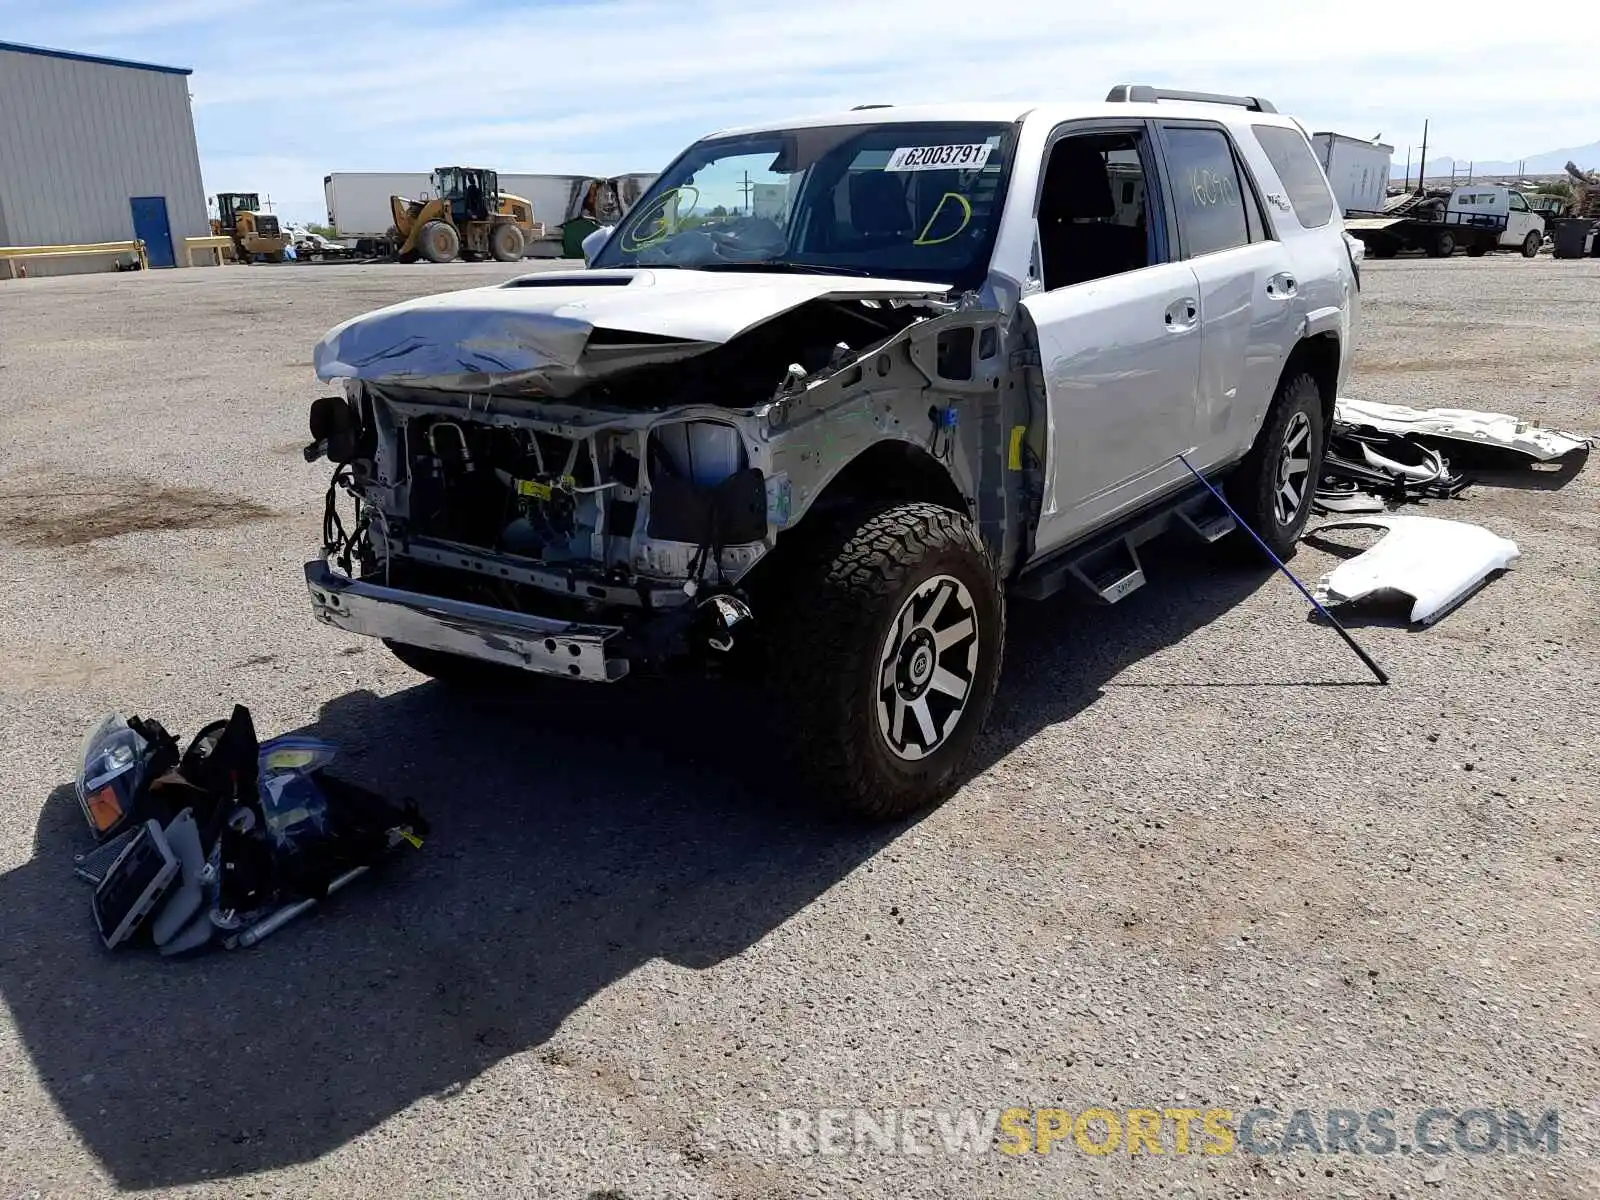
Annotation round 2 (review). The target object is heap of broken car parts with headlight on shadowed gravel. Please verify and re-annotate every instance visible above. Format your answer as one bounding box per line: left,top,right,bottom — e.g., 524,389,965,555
75,706,427,957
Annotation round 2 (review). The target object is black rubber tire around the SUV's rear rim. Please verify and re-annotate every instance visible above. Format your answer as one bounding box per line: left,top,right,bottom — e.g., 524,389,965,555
1226,371,1328,562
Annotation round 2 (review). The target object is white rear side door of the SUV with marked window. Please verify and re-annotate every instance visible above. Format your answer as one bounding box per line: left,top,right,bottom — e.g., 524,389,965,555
1160,120,1305,469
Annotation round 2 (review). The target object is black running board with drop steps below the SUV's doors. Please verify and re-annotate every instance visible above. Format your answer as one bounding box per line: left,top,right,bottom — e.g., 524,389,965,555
1011,485,1238,605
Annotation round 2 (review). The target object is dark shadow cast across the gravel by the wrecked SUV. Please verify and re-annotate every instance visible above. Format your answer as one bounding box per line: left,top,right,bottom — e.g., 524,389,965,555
0,534,1273,1189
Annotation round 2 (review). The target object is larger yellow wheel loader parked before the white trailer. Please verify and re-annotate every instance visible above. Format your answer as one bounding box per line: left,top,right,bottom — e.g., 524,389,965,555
389,166,538,262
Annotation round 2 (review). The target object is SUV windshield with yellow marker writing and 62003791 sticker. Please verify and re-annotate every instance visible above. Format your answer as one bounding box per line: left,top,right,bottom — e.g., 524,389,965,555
594,122,1013,286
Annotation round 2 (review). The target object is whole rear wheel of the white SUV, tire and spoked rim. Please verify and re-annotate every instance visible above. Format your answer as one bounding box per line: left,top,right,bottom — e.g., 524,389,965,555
1227,373,1328,558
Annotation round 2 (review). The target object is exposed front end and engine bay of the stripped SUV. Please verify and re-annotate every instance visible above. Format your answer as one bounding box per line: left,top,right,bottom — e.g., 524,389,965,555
307,276,1032,678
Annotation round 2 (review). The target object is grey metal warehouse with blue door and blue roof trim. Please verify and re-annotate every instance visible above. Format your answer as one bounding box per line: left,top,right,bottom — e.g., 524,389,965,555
0,42,211,275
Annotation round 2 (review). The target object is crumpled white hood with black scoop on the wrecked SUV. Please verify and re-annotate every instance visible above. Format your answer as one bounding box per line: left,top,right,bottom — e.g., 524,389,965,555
314,269,949,395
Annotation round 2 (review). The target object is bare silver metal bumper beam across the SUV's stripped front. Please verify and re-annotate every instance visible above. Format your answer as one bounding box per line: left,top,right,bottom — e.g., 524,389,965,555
306,558,629,683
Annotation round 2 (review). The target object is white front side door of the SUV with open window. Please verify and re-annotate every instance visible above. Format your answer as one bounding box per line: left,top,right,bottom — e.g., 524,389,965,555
1022,122,1200,554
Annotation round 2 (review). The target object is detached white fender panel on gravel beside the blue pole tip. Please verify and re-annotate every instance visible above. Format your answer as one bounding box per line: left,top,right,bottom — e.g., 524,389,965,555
1315,517,1520,626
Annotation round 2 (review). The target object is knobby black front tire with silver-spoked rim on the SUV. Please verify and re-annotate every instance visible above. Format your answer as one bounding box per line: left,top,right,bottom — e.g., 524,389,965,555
766,502,1005,821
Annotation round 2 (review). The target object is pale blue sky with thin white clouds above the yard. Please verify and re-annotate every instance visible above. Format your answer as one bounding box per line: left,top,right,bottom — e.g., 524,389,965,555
0,0,1600,221
